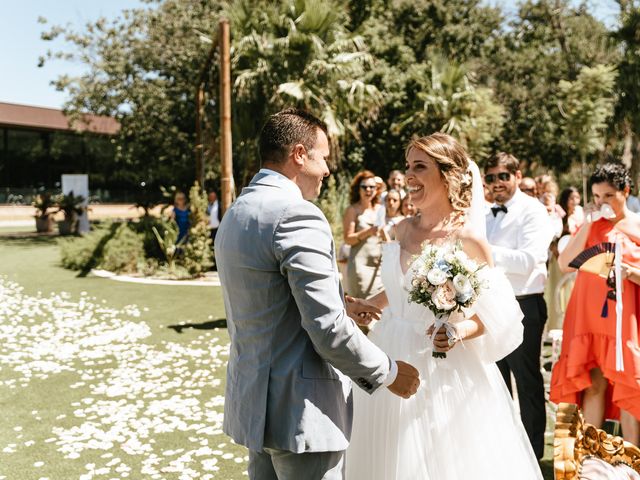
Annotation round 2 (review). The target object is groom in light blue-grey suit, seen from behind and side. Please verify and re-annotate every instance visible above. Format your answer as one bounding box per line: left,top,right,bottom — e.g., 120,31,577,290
215,109,420,480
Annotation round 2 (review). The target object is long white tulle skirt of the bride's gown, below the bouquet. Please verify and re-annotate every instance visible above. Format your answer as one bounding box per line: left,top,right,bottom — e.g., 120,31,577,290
346,312,542,480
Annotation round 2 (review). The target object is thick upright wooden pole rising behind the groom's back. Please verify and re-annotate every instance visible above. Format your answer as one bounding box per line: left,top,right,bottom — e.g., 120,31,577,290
218,18,233,214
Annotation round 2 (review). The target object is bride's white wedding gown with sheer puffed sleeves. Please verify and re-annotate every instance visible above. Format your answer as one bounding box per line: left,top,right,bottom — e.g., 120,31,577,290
346,242,542,480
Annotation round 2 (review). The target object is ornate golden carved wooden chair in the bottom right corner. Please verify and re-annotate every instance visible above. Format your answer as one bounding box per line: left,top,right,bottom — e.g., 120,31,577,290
553,403,640,480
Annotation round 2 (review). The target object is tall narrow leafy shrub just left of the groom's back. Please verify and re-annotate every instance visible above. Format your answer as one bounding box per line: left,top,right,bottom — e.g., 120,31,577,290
182,183,213,277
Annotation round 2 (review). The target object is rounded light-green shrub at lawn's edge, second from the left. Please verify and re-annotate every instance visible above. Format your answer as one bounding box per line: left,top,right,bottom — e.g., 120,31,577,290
100,224,145,273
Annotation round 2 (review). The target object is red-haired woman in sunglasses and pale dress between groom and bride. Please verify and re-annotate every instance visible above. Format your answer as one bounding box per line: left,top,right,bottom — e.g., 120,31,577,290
343,170,383,298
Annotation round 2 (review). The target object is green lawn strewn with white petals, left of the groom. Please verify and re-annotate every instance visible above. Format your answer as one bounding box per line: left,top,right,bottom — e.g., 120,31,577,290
0,236,553,480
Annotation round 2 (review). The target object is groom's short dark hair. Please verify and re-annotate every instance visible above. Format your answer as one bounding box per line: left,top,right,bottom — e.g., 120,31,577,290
260,108,327,164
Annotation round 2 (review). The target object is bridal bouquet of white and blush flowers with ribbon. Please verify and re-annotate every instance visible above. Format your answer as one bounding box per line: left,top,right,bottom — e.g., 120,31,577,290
409,242,484,358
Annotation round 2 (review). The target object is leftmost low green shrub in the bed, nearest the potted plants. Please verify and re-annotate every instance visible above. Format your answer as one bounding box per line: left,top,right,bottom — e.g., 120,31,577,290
58,222,119,273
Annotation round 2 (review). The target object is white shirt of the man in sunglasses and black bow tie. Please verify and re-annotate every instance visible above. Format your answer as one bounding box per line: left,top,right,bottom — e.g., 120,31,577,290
487,189,553,296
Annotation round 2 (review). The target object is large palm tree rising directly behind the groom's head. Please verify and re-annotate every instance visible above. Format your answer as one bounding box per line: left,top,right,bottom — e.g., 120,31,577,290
228,0,381,180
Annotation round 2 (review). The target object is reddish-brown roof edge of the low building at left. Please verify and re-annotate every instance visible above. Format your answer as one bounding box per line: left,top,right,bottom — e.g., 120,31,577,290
0,102,120,135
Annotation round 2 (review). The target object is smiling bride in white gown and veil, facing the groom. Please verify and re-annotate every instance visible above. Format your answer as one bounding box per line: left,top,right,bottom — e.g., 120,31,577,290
346,133,542,480
